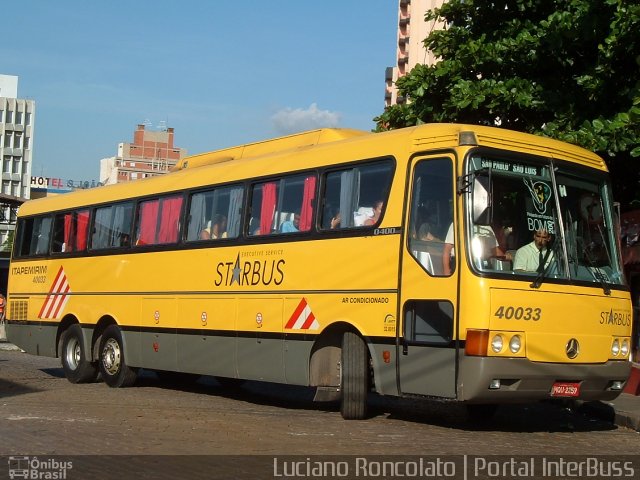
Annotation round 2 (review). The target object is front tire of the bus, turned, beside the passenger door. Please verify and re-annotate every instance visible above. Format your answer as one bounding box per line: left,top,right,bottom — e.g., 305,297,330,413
340,332,369,420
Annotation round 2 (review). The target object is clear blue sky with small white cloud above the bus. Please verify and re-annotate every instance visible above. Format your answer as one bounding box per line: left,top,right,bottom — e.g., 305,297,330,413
0,0,398,181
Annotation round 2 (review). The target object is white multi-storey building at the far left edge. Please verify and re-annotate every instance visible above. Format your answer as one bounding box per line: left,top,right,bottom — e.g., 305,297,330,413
0,75,36,247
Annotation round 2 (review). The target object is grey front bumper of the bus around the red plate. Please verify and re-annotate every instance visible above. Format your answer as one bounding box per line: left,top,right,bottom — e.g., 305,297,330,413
457,355,631,403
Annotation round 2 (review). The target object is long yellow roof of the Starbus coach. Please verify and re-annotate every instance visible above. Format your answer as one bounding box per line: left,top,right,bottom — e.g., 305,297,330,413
18,124,607,216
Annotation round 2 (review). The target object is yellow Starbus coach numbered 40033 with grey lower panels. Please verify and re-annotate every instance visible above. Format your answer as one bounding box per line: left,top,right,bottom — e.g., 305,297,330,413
7,124,632,419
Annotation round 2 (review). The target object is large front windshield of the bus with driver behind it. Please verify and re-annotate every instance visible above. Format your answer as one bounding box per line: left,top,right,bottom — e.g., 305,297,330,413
467,154,624,284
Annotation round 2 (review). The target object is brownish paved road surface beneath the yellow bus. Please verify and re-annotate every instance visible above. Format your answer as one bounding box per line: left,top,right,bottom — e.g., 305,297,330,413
0,351,640,478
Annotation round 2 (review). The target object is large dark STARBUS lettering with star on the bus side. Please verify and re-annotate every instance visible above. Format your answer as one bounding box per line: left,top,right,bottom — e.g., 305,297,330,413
214,254,285,287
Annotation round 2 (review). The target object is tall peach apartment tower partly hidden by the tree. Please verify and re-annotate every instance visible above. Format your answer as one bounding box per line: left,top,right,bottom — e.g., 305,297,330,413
384,0,446,107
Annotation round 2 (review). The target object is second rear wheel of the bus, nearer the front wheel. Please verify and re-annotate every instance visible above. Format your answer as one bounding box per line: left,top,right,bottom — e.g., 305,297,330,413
100,325,138,388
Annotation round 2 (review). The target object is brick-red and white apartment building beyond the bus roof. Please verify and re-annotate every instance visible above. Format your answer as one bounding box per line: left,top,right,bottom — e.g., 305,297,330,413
100,124,187,185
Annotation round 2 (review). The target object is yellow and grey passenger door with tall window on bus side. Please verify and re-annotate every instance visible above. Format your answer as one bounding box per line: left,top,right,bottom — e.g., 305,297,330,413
397,155,458,398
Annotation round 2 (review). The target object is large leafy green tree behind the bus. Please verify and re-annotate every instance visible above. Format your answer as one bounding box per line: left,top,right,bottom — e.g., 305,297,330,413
375,0,640,203
